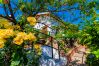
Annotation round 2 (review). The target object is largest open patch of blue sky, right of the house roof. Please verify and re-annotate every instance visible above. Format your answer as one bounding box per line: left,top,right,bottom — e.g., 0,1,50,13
57,10,81,24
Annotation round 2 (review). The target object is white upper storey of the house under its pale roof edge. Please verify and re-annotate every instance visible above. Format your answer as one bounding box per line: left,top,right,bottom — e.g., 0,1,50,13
34,12,51,32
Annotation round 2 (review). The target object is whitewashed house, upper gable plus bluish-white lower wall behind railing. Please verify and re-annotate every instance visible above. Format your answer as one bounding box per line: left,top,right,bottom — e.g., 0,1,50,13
34,12,67,66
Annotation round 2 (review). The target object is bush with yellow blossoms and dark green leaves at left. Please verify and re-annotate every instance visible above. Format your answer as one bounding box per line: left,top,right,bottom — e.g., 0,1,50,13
0,16,41,66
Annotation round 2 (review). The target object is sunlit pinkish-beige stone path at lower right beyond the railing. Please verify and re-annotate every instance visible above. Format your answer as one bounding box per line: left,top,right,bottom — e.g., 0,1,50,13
68,46,86,66
